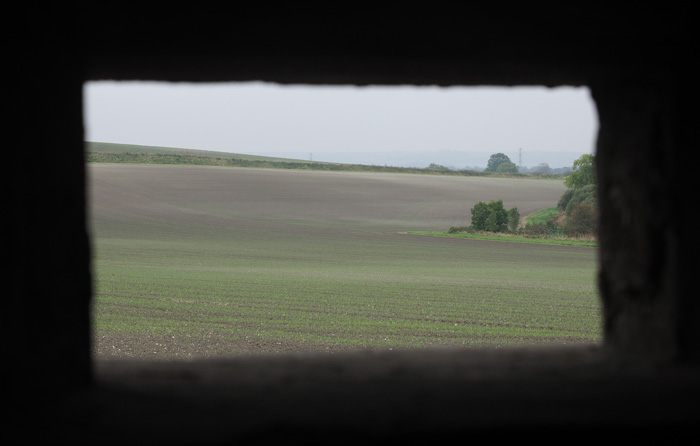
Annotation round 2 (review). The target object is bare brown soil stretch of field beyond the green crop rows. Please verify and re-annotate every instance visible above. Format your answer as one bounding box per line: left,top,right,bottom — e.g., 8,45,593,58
89,164,565,232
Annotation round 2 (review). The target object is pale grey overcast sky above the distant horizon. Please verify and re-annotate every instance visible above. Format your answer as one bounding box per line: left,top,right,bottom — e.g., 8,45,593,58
85,82,597,167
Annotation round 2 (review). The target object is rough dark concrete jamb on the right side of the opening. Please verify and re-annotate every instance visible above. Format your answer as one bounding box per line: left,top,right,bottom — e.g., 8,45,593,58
592,76,700,362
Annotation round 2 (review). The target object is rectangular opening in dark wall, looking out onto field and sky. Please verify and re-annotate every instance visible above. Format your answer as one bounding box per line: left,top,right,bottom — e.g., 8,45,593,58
85,82,601,359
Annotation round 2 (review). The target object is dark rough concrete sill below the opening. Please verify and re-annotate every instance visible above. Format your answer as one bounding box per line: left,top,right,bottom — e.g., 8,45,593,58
21,346,700,444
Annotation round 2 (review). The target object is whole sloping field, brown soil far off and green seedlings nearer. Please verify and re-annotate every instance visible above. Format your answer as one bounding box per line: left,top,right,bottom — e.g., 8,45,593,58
88,164,601,359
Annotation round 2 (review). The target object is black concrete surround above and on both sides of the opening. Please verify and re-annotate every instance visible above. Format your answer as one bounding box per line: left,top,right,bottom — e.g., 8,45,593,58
9,5,700,422
